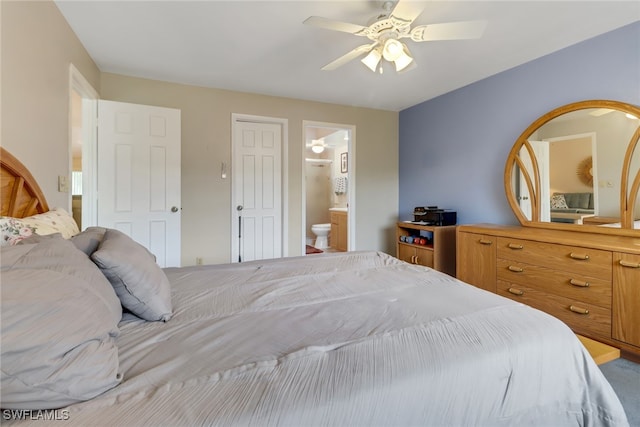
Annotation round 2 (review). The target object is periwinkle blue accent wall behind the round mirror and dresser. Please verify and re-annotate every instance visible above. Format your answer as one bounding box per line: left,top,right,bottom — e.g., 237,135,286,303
399,22,640,224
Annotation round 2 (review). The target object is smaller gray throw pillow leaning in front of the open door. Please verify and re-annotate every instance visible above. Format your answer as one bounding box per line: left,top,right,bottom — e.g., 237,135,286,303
91,229,172,322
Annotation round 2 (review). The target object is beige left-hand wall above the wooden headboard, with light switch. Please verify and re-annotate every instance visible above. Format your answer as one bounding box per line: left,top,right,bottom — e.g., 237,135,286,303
0,0,100,210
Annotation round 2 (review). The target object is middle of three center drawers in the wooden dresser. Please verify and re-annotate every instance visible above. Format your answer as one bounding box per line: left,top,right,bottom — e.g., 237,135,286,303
497,259,611,309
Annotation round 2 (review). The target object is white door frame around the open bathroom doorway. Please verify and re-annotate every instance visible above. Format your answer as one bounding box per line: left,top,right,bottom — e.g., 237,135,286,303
300,120,356,255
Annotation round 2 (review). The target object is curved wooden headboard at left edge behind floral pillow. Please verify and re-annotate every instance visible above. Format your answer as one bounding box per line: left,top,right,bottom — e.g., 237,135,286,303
0,147,49,218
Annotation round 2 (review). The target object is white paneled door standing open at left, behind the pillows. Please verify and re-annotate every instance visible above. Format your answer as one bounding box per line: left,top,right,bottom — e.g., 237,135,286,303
98,100,181,267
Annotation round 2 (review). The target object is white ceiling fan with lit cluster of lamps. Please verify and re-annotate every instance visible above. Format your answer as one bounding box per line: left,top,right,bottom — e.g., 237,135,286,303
304,0,486,73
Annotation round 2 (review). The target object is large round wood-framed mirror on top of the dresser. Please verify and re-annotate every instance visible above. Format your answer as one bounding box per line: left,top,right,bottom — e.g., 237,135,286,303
504,100,640,235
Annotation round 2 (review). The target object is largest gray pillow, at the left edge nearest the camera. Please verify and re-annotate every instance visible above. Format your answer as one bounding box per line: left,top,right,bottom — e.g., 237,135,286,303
0,237,122,409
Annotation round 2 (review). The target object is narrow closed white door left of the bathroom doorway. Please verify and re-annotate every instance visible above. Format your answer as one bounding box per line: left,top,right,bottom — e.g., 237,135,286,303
231,121,283,262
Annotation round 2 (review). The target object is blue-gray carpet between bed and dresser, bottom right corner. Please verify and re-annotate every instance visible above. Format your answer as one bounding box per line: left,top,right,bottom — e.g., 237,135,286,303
600,359,640,427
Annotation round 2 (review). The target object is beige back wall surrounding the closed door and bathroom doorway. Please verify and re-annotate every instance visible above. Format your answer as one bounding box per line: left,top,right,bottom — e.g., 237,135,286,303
100,73,398,265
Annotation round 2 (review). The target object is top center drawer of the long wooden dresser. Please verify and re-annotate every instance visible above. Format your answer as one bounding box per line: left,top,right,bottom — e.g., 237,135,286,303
498,237,613,281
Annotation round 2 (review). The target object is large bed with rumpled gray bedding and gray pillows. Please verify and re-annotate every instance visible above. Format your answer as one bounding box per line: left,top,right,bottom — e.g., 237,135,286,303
1,146,628,426
